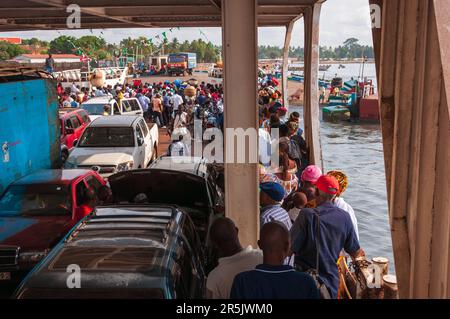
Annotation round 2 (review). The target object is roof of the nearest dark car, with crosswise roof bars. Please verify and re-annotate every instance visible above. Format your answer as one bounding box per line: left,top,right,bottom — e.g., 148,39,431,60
16,205,186,289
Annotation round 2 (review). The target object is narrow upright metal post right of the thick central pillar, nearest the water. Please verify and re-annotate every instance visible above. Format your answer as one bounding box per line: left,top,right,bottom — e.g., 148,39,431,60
303,3,323,167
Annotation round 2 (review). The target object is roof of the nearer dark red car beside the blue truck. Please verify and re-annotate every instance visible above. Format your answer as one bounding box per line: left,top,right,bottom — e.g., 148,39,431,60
12,169,91,185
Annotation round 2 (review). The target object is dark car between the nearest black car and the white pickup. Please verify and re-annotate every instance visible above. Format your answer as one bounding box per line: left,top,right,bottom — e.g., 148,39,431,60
112,157,224,246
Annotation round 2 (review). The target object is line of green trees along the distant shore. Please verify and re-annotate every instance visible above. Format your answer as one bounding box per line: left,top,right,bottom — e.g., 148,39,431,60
0,35,374,63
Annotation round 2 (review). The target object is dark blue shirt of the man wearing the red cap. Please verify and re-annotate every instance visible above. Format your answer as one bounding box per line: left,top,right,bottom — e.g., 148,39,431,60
291,202,360,298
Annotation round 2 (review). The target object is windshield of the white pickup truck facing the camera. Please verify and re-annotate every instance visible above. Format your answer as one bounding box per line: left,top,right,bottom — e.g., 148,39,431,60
78,127,134,147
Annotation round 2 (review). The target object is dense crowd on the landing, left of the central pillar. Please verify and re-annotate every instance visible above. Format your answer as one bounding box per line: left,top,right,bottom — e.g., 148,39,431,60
57,80,223,138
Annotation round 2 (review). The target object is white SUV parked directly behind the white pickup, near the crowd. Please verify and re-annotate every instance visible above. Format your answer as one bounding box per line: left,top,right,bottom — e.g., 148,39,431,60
81,95,144,121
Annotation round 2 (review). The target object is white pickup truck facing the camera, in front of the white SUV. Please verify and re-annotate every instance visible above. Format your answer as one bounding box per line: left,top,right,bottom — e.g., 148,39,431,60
65,115,158,177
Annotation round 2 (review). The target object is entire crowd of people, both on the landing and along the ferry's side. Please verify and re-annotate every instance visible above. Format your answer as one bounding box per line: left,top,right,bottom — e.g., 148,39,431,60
58,67,365,299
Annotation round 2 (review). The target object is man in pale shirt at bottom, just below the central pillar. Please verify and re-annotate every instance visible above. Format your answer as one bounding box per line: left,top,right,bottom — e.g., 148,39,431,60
206,217,263,299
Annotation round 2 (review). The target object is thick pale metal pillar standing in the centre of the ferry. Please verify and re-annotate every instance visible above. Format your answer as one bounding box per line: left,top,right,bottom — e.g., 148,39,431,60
222,0,259,247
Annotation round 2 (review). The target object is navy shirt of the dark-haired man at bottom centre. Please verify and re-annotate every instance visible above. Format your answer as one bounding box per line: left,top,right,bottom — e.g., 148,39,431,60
230,264,320,299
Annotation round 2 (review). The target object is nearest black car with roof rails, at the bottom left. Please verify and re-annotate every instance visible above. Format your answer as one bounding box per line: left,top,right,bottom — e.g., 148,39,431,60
15,205,205,299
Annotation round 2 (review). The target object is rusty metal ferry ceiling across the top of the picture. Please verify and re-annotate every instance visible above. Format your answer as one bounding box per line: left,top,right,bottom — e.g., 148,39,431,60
0,0,325,31
